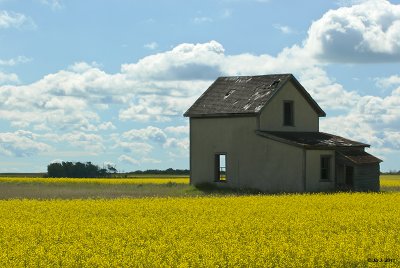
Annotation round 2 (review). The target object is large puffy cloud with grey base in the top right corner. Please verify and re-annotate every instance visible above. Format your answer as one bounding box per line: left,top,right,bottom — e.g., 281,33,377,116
305,0,400,62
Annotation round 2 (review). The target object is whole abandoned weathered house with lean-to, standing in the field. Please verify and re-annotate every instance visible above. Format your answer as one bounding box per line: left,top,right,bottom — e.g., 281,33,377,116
184,74,381,192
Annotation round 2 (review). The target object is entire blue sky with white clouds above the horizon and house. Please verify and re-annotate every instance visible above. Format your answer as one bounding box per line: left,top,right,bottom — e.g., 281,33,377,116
0,0,400,172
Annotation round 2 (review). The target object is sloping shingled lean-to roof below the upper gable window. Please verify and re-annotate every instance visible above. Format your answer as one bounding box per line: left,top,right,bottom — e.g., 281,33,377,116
256,130,369,149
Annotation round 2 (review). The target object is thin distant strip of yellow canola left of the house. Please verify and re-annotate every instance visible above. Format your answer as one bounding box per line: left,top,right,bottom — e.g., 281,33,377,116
0,177,189,184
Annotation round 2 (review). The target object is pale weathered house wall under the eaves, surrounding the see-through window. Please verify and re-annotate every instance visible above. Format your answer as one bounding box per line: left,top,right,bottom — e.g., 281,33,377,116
190,117,303,192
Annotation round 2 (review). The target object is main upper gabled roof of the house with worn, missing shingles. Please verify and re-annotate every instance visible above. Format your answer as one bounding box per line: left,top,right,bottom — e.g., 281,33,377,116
184,74,325,117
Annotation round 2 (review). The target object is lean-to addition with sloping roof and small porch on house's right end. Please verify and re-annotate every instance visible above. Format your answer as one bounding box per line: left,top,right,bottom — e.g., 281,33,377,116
256,131,382,191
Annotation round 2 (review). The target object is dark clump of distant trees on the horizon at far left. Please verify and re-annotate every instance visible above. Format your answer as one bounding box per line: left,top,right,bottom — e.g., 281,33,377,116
46,162,117,178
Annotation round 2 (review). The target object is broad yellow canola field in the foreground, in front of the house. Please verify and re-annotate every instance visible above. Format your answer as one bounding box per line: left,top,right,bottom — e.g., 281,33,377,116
0,193,400,267
